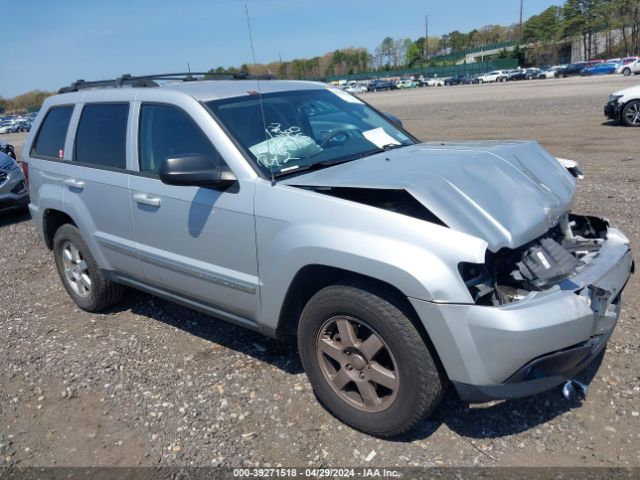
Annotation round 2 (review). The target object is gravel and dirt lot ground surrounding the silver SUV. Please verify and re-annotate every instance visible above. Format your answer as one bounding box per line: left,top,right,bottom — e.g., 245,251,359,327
0,77,640,467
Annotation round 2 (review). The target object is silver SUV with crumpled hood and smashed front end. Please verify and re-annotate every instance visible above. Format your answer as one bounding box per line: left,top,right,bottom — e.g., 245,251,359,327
24,76,633,436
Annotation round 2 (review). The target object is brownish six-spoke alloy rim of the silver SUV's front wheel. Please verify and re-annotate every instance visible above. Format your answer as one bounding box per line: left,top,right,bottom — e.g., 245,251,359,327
316,316,399,413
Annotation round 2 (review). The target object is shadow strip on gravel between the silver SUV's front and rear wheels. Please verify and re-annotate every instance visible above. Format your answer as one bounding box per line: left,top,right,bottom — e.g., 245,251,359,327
112,290,304,375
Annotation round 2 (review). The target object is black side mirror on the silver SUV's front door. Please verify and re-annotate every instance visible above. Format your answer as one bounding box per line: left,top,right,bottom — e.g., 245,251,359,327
158,155,237,188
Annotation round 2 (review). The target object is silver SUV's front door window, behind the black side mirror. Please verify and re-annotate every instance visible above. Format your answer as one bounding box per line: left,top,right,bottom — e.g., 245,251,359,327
139,105,222,172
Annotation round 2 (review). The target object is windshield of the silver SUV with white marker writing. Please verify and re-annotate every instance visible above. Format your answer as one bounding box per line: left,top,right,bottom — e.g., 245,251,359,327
207,89,414,176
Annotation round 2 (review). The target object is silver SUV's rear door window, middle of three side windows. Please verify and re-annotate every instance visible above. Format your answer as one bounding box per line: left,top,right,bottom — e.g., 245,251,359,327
74,103,129,168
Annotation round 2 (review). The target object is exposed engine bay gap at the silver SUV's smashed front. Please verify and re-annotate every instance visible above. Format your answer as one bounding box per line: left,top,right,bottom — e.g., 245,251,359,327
460,214,608,305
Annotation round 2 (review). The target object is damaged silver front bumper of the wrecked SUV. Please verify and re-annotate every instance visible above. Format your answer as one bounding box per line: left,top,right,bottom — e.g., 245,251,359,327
411,226,633,401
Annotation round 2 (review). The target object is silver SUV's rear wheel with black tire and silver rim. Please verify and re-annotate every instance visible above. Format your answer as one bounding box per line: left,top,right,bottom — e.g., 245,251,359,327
53,224,125,312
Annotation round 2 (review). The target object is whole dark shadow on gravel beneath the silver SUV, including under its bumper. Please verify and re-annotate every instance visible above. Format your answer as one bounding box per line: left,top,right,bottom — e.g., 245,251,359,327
105,290,604,443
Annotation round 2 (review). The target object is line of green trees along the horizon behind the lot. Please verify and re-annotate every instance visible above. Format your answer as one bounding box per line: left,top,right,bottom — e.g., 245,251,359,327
210,0,640,79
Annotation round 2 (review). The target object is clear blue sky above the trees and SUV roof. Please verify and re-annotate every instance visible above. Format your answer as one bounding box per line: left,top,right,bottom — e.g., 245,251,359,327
0,0,560,98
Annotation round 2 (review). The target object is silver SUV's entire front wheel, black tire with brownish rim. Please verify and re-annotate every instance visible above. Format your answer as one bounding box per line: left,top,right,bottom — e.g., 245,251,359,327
298,285,445,437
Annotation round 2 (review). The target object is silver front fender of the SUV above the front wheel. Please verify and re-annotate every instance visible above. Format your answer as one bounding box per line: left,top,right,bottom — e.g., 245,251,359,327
256,180,486,328
